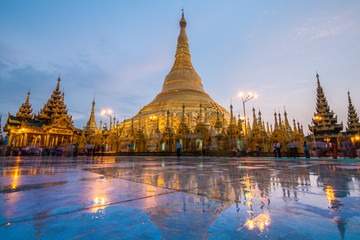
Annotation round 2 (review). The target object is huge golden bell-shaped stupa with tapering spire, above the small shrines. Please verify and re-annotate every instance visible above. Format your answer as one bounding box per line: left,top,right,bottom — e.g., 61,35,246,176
136,12,230,119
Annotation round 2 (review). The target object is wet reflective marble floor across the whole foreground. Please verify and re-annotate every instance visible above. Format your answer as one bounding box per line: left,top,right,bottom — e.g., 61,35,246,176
0,157,360,240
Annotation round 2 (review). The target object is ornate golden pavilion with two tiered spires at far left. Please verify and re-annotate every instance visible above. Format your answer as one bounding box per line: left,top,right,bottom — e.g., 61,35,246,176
4,76,79,147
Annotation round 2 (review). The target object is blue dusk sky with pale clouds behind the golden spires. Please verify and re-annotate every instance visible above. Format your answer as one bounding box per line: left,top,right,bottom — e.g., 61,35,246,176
0,0,360,132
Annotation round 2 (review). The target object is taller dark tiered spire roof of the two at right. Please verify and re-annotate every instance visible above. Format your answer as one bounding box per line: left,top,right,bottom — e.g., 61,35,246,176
309,74,343,140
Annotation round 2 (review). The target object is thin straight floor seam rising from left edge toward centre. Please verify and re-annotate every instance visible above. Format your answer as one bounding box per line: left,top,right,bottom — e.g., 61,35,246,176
0,191,177,227
